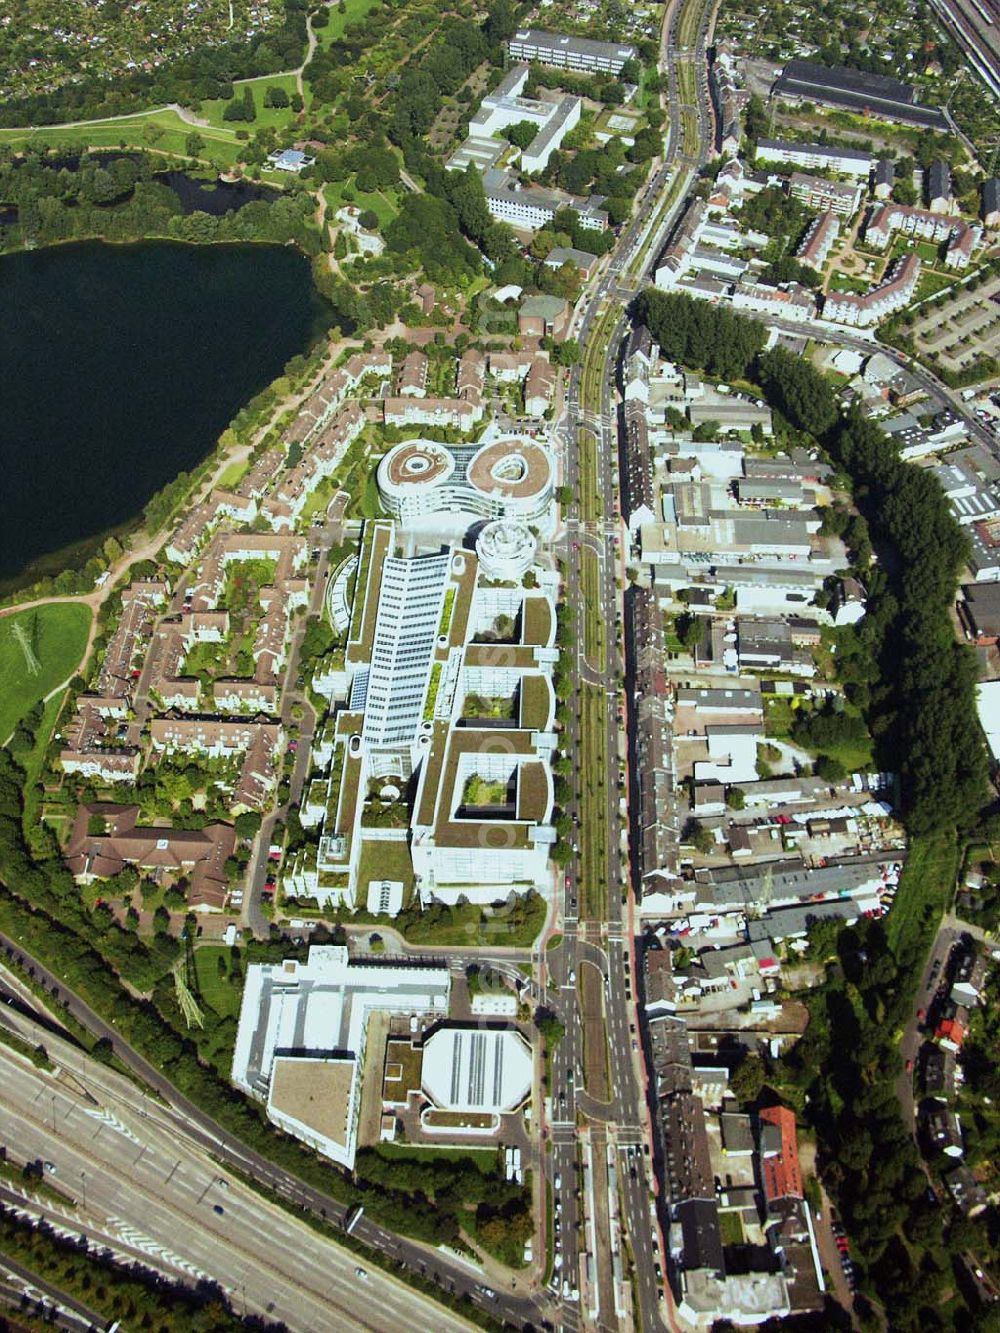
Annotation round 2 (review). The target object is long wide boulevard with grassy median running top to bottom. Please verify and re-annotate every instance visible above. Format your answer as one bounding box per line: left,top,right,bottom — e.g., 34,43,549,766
545,0,712,1329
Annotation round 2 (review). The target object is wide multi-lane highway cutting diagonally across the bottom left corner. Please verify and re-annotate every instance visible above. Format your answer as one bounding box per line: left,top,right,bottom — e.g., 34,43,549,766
0,1010,468,1333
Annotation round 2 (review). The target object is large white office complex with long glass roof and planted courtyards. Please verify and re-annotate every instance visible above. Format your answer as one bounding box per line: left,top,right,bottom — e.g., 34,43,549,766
285,517,559,905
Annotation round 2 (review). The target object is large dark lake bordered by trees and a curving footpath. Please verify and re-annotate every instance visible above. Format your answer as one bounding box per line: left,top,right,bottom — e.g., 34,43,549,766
0,241,327,581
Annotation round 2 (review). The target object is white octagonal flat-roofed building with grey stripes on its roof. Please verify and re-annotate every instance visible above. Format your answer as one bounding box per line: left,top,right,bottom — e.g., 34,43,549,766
421,1028,532,1110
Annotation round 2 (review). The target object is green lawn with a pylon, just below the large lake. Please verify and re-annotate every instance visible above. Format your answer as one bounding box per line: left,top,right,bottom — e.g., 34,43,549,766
0,601,91,741
